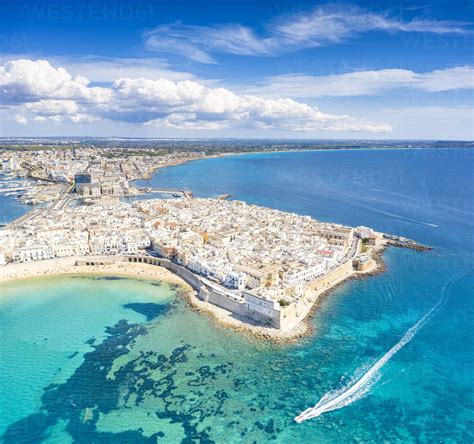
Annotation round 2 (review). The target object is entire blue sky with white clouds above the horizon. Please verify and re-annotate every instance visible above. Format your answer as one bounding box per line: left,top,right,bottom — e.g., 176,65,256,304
0,0,474,140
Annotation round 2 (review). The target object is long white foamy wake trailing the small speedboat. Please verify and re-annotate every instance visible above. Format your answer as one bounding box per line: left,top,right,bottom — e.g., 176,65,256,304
295,298,444,423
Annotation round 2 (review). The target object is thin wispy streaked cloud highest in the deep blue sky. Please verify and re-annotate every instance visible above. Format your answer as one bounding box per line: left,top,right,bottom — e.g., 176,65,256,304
143,4,472,63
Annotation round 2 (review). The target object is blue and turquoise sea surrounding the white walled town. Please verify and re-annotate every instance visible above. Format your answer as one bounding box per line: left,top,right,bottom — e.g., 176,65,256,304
0,149,474,443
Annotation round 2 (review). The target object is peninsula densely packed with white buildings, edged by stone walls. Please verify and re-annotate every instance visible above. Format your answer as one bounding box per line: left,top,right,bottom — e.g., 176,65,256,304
0,146,428,339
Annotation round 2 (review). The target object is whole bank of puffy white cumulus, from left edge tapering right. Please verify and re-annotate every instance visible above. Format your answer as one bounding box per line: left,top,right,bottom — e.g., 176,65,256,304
0,60,391,133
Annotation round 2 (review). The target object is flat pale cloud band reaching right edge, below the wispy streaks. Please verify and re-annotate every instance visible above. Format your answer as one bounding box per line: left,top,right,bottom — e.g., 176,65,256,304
245,66,474,98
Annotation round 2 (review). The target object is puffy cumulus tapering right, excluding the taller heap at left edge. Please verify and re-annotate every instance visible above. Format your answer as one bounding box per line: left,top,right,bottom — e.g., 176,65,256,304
114,73,390,132
